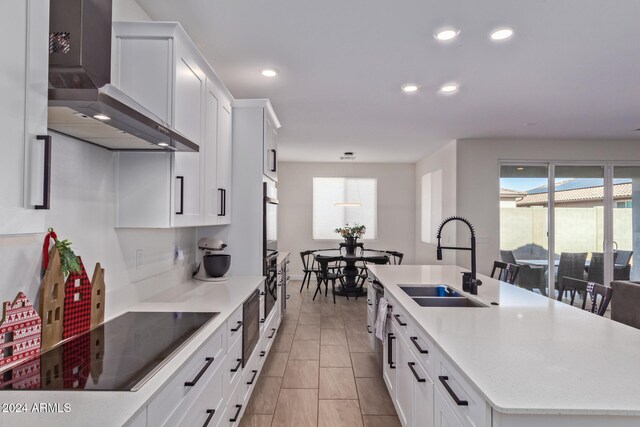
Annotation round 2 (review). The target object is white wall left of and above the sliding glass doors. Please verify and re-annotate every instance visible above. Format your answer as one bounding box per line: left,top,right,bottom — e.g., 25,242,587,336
456,139,640,274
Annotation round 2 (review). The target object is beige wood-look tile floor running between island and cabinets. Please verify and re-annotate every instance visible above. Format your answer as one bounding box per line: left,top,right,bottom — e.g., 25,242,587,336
240,281,400,427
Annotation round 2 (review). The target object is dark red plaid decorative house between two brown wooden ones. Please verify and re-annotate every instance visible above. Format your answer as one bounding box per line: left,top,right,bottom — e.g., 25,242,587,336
62,257,91,339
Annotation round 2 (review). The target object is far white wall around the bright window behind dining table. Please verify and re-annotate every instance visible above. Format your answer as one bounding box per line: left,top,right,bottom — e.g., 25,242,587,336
278,162,415,276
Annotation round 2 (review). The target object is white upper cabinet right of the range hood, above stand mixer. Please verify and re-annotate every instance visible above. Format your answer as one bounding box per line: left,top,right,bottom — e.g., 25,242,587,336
113,22,232,227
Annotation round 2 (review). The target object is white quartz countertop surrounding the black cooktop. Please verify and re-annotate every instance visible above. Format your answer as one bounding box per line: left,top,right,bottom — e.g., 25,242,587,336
0,276,264,427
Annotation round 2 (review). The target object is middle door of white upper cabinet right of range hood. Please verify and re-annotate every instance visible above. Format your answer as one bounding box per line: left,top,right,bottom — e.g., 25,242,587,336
200,79,221,225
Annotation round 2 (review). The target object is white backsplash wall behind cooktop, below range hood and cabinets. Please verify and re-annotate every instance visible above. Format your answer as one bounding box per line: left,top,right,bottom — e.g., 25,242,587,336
0,0,195,318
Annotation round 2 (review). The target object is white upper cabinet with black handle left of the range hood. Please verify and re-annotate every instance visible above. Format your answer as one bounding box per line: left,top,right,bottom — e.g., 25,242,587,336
0,0,50,235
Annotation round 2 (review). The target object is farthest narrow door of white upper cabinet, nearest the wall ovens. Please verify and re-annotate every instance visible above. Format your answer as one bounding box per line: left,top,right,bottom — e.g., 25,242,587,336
217,101,232,224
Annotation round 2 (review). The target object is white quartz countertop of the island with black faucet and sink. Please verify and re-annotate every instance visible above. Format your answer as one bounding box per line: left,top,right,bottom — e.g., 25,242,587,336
369,265,640,415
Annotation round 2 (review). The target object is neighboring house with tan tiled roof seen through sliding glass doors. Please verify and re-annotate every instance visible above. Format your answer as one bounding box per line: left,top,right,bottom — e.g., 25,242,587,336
516,178,632,208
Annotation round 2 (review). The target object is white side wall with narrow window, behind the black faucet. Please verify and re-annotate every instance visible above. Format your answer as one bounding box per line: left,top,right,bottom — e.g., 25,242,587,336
415,141,457,264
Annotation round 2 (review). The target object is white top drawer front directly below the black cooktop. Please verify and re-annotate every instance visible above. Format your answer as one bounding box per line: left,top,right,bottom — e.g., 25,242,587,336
147,328,225,426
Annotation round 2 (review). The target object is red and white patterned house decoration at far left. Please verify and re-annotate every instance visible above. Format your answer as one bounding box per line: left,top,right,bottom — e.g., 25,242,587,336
0,292,42,370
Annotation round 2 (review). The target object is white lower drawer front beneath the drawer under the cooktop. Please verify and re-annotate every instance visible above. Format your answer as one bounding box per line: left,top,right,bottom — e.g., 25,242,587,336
174,358,226,427
